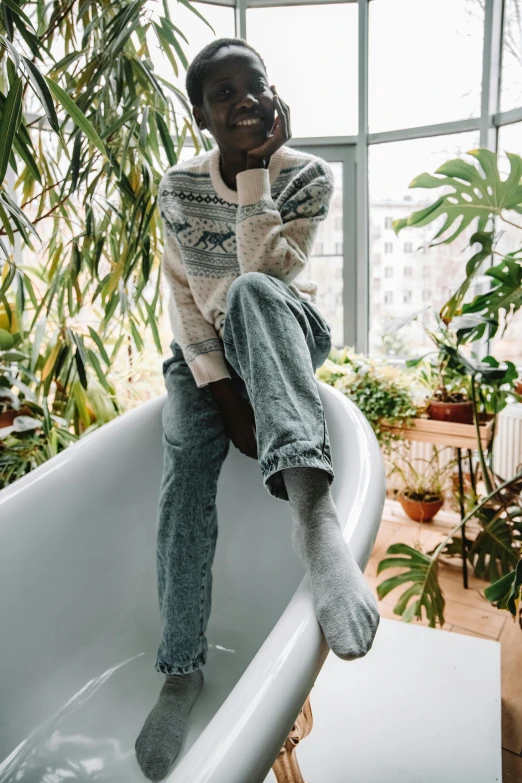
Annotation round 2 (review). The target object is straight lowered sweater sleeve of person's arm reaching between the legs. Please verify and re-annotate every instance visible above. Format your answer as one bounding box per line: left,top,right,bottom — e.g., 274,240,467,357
162,234,230,386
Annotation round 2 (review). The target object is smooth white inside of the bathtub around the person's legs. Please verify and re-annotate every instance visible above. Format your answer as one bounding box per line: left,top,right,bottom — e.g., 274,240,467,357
0,389,368,783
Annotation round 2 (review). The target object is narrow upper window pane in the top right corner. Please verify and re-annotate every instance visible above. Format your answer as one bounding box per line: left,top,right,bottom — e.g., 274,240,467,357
500,0,522,113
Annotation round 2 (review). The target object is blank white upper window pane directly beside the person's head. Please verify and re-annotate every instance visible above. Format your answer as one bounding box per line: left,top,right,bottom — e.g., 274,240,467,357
247,3,357,137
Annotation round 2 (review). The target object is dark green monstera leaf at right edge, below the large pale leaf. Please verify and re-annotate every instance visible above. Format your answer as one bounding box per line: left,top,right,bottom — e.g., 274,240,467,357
462,251,522,337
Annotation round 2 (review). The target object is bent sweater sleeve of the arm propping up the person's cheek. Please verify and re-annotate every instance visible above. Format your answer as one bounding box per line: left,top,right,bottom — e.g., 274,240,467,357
236,160,333,284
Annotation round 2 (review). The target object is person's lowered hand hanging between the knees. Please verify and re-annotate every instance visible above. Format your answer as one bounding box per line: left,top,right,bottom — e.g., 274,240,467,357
208,378,257,459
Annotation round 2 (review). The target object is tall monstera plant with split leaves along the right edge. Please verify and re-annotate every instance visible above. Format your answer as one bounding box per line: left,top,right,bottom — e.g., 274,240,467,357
377,149,522,628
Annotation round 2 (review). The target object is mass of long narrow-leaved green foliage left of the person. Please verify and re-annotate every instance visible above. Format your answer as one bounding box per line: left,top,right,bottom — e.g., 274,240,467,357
0,0,211,487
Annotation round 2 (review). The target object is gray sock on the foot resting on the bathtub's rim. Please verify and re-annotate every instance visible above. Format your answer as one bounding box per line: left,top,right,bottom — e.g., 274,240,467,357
283,467,380,661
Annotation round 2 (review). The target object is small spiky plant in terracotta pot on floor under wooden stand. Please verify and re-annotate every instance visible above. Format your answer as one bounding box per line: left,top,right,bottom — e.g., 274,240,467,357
390,446,456,522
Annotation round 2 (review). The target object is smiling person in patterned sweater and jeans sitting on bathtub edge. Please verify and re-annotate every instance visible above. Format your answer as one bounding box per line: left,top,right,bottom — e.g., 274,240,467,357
136,38,379,780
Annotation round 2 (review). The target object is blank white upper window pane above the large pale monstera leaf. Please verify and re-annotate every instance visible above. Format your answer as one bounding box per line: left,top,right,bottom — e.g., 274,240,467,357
368,0,482,133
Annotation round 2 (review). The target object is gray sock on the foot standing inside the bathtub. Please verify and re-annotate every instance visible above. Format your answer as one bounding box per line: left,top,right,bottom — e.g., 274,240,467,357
135,669,203,780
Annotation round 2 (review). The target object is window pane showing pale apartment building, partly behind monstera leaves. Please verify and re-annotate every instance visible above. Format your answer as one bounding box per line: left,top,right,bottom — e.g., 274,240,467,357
368,132,478,357
